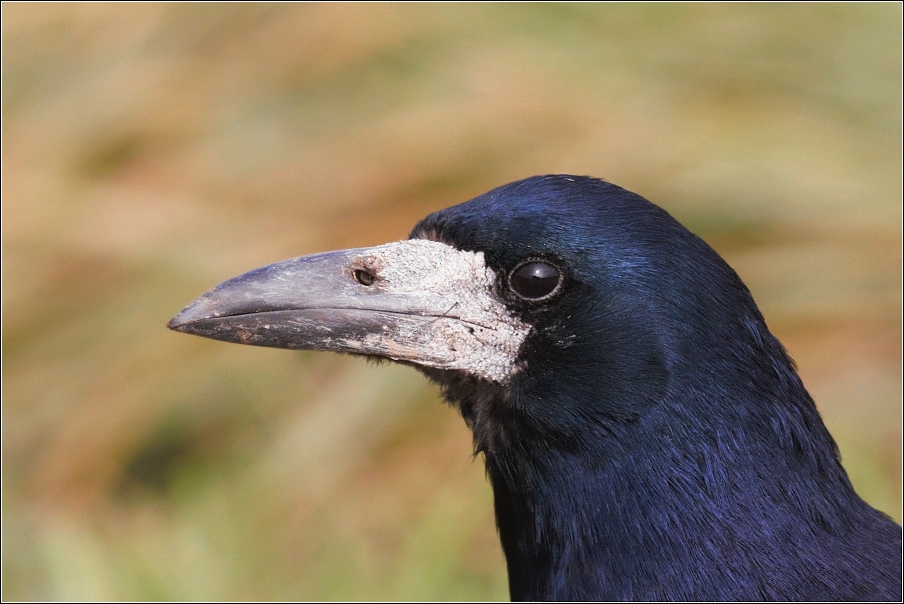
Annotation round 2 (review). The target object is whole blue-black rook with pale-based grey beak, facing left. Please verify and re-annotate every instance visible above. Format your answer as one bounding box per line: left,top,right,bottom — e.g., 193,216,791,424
169,176,902,601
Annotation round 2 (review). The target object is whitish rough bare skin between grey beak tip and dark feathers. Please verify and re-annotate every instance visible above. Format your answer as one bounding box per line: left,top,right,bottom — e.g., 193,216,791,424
345,239,530,383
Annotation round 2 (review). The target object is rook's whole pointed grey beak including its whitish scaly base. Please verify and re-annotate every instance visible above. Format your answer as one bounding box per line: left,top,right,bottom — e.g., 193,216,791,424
168,240,528,381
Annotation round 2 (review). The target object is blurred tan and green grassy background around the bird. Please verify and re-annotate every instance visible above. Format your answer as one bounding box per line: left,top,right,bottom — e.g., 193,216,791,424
2,3,902,600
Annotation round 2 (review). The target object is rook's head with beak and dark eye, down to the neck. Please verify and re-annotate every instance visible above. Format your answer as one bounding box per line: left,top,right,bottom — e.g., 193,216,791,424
169,175,765,448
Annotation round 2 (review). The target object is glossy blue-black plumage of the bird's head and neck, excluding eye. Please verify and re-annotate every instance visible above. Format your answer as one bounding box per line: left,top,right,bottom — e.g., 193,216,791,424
412,176,902,601
